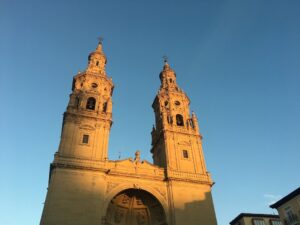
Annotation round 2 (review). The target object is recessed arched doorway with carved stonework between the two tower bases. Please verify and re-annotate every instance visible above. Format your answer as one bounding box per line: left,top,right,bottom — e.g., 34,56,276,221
106,189,167,225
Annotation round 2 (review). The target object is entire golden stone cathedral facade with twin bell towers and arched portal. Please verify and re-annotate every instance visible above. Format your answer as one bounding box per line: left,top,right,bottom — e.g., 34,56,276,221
40,43,217,225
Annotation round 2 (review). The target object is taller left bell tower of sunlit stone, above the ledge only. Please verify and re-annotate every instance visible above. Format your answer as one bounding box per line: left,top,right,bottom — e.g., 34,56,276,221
56,42,114,161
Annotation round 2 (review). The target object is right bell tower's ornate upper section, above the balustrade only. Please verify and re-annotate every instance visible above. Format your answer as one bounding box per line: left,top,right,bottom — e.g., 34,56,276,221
151,61,206,174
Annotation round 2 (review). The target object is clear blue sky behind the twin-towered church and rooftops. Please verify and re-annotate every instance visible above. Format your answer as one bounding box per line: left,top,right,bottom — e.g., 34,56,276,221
0,0,300,225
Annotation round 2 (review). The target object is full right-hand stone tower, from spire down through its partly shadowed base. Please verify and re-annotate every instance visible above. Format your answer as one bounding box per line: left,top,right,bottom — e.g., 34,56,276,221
151,60,217,225
